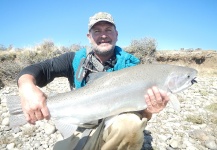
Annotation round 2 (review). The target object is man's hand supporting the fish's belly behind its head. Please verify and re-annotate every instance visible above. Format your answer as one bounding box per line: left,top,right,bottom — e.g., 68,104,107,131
142,86,169,120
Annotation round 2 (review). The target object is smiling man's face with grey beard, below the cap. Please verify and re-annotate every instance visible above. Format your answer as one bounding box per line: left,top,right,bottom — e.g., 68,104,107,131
87,21,118,56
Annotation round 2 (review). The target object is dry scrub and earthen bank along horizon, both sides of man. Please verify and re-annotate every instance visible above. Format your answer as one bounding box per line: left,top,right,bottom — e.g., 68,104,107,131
0,37,217,87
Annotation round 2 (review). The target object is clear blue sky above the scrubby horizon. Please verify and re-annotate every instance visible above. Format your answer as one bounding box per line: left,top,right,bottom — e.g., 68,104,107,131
0,0,217,50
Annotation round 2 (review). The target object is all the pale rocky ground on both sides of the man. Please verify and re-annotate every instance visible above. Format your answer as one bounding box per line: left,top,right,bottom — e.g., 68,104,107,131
0,76,217,150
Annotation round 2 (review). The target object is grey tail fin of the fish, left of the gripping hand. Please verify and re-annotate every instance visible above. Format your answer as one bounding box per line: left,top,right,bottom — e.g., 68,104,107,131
7,96,27,127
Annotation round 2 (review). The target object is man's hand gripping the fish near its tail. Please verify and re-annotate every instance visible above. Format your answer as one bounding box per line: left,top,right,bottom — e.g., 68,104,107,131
18,75,50,124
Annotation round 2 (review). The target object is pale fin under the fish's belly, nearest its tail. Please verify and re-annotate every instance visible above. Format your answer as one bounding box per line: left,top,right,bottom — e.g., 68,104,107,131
54,119,78,139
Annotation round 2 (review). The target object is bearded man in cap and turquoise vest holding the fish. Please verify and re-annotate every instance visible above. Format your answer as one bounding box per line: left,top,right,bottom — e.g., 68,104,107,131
18,12,169,150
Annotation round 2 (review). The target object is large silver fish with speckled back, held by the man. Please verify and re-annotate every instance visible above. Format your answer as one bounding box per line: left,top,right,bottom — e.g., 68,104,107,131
7,64,197,137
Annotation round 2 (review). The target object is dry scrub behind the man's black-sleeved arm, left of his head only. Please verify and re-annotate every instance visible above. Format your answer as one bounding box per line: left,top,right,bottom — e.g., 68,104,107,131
0,40,84,85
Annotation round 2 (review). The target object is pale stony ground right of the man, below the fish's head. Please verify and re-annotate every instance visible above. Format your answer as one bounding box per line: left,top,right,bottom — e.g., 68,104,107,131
144,77,217,150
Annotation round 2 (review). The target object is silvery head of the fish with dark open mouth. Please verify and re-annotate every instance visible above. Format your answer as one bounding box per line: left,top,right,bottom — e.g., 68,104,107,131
166,66,197,93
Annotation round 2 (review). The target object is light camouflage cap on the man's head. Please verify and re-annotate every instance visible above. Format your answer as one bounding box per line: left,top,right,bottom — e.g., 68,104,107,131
88,12,115,30
